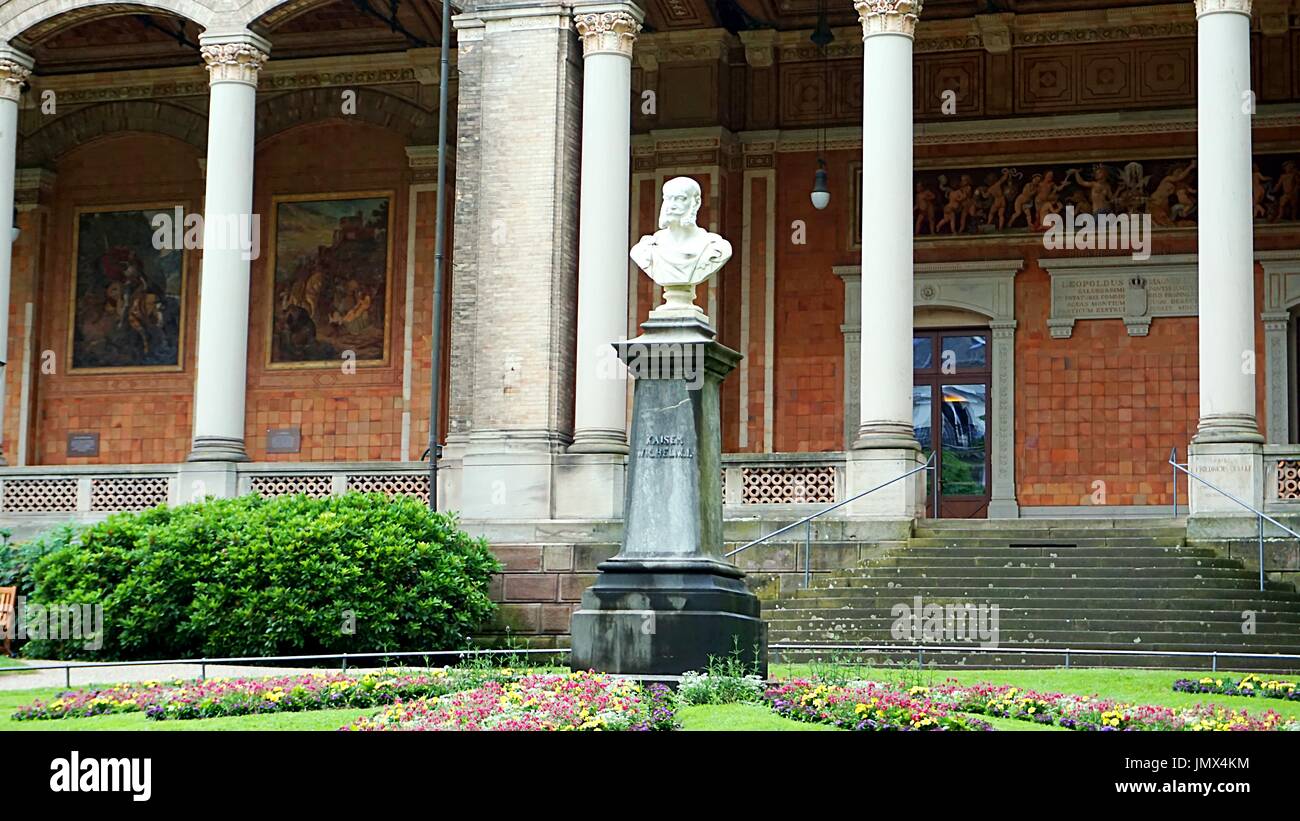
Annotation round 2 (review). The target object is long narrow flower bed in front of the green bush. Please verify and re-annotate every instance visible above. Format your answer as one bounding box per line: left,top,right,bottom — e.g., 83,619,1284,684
13,668,519,721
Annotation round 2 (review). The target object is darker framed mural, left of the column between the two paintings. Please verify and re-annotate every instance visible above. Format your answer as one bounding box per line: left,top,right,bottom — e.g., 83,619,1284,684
68,203,186,373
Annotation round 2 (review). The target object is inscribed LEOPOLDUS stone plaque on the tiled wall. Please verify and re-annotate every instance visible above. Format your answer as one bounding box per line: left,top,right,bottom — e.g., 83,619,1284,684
1041,257,1197,339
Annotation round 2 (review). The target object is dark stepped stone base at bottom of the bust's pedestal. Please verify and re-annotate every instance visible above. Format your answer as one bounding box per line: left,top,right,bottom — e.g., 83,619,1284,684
572,559,767,678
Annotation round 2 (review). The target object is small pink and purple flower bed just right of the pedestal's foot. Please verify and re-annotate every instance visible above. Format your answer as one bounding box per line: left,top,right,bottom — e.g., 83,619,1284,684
766,679,992,730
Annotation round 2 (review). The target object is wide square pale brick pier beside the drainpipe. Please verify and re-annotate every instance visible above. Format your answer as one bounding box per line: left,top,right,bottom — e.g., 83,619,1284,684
449,0,582,522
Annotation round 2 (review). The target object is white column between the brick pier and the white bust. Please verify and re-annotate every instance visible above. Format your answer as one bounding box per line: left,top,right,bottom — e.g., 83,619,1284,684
568,4,642,453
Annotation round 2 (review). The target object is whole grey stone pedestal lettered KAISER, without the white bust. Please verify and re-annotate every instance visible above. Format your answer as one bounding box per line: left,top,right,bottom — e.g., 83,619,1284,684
572,318,767,676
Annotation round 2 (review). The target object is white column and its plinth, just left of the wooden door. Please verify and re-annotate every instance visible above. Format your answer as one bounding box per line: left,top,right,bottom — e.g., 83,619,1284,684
849,0,924,526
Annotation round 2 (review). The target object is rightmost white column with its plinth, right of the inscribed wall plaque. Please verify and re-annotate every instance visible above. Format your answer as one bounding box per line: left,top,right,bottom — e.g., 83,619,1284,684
1191,0,1264,517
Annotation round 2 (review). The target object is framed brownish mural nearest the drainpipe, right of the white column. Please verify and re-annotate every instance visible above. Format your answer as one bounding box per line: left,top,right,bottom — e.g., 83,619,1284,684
267,191,393,368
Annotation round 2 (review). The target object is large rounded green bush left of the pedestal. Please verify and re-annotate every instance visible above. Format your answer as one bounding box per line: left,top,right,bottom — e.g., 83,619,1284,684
23,494,499,660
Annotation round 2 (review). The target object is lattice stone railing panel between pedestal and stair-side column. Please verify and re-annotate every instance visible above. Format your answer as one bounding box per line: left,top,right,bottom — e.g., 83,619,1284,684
723,453,844,505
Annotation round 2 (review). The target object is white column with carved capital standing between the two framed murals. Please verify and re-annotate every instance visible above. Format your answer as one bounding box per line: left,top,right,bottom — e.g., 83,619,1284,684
190,31,270,461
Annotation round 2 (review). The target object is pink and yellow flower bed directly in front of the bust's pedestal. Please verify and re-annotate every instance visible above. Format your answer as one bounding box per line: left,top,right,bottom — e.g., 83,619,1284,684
343,672,676,730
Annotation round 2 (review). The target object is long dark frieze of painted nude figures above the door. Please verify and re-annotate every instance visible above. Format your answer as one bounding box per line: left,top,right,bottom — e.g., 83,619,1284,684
899,155,1300,236
